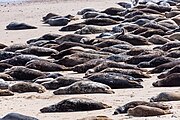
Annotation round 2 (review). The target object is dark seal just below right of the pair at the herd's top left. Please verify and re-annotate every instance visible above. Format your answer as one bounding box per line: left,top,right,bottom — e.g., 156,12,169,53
59,23,85,31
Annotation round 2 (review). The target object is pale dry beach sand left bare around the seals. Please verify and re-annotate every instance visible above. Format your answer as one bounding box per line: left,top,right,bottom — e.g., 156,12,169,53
0,0,180,120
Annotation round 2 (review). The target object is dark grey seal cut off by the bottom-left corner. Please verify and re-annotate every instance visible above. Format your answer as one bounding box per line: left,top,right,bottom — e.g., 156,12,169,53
2,113,38,120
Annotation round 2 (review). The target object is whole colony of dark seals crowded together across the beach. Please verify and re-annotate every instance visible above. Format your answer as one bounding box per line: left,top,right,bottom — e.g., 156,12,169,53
0,0,180,119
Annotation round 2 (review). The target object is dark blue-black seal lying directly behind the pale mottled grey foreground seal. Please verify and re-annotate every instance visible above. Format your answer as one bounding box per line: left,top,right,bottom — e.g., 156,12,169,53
87,73,143,89
